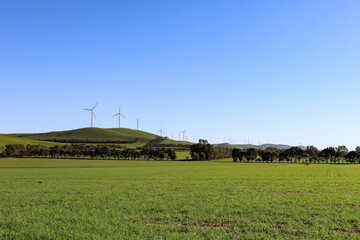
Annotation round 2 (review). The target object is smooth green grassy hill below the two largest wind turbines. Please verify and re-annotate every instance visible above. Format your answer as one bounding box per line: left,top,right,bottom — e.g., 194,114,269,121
0,128,191,147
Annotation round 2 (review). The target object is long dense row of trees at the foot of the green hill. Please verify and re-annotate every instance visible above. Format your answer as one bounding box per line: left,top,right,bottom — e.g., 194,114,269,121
0,144,176,160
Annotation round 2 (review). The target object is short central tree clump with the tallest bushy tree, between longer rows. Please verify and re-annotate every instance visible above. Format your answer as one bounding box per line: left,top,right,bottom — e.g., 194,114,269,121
190,139,232,160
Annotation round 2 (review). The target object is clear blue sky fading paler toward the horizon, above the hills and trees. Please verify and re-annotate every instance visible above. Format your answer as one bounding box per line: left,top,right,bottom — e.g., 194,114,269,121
0,0,360,149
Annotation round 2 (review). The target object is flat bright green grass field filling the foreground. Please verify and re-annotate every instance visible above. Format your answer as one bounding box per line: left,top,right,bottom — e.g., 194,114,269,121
0,159,360,239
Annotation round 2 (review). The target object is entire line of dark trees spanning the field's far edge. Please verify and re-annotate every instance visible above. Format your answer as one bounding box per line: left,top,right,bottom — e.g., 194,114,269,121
0,142,360,164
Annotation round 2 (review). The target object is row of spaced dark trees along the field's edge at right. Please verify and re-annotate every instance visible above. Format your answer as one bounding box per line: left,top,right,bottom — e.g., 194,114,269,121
232,145,360,163
